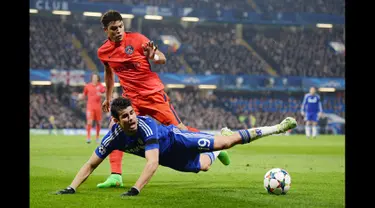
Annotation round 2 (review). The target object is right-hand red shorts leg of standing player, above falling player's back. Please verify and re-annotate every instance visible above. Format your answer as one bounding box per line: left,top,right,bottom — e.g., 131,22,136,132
140,91,181,126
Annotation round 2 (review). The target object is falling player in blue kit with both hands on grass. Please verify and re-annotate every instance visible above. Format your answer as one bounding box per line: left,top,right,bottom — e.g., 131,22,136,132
56,97,297,196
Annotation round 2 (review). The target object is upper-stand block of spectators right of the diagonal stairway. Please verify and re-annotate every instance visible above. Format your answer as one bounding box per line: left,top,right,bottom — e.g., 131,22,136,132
244,26,345,77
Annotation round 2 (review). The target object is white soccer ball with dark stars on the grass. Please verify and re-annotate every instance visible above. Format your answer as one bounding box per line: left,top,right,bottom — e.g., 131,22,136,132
264,168,292,195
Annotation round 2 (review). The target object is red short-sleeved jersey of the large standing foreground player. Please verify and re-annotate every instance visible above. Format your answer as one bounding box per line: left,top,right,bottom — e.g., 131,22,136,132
98,32,164,97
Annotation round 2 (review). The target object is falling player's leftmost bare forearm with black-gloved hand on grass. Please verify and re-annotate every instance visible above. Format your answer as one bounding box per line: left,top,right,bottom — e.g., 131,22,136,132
56,152,103,194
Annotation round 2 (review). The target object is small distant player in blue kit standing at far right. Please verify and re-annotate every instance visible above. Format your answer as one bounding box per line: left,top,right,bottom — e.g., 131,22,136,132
301,87,323,139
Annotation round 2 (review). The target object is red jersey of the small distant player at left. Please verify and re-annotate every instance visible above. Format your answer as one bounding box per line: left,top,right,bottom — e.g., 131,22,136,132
83,83,105,110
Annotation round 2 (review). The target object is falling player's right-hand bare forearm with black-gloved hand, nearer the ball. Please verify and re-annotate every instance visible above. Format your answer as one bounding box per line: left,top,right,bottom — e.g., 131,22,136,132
121,149,159,196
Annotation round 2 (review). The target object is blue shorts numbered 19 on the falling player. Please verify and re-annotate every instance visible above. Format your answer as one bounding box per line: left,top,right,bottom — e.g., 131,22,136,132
159,128,214,173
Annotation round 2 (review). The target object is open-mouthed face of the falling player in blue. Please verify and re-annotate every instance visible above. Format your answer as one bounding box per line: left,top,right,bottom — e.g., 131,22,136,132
118,106,138,133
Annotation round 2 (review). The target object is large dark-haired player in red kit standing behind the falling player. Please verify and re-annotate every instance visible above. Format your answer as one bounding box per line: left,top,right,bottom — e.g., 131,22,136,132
94,10,217,188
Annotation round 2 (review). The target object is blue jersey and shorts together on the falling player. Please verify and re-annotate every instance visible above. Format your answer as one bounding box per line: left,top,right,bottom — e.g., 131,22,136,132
95,116,220,172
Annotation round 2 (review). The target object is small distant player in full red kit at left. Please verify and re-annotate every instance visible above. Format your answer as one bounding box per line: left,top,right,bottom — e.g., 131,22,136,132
83,74,105,144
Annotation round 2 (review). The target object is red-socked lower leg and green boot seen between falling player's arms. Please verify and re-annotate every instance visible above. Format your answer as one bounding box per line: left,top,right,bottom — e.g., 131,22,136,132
96,119,124,188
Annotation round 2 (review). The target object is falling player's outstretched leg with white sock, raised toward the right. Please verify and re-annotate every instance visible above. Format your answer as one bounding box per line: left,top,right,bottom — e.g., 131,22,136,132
214,117,297,150
